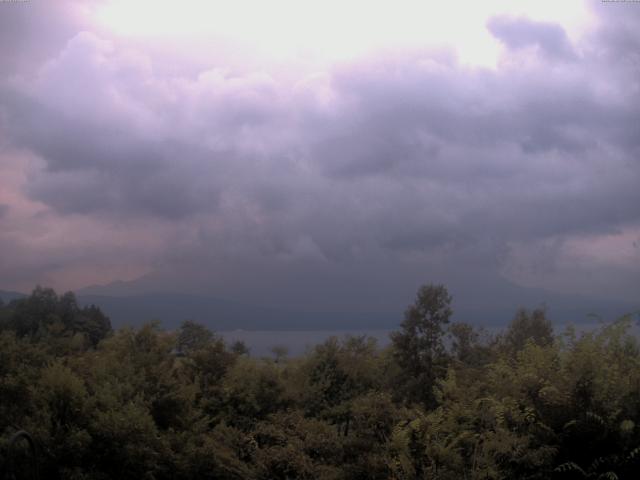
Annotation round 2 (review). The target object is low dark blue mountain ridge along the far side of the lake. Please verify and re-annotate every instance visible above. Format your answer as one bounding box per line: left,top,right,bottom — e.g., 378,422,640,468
0,281,640,331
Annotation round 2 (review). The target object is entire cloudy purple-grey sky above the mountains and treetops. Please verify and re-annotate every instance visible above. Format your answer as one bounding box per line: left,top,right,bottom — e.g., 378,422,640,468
0,0,640,309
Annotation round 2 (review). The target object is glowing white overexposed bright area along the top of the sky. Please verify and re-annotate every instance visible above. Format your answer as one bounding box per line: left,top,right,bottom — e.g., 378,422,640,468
97,0,589,66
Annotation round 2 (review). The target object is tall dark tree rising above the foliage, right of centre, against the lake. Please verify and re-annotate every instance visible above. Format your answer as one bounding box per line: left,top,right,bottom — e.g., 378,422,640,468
391,285,453,407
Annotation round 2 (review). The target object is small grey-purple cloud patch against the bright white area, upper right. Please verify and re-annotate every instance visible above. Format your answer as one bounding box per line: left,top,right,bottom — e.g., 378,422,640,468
487,16,576,60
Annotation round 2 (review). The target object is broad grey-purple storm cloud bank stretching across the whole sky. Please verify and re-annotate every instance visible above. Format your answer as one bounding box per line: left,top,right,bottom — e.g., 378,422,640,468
0,2,640,304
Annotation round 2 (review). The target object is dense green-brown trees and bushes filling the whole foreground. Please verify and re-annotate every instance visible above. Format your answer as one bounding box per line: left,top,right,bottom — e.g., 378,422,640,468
0,286,640,480
